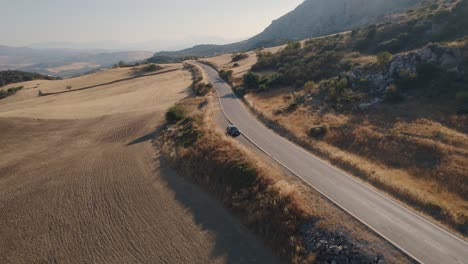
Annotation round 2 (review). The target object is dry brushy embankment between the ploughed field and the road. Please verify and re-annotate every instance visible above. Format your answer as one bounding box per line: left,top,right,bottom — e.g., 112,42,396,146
159,89,409,263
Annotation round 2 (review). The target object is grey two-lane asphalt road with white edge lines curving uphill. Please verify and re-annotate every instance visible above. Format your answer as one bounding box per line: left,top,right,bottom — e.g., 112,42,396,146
198,63,468,264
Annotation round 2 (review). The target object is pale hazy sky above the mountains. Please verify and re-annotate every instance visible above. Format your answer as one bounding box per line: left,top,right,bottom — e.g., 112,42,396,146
0,0,303,46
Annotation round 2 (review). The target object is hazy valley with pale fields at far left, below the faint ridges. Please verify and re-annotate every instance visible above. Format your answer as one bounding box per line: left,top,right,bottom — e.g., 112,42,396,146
0,46,153,77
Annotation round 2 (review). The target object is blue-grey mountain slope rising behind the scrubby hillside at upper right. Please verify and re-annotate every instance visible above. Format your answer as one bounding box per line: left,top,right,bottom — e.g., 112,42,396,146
155,0,422,57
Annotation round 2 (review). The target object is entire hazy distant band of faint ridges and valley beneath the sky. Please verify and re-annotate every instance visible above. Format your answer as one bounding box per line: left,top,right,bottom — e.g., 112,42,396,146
0,36,245,77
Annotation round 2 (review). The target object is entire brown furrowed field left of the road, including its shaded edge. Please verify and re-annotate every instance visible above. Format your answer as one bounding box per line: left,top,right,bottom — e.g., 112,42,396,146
0,65,276,263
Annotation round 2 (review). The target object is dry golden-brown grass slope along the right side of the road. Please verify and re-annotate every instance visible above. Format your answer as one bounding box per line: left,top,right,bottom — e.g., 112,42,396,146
204,36,468,235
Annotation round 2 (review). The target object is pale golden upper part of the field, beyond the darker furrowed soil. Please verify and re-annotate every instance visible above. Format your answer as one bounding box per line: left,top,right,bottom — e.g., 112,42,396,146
0,65,186,119
